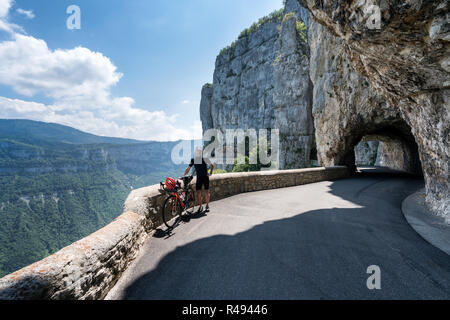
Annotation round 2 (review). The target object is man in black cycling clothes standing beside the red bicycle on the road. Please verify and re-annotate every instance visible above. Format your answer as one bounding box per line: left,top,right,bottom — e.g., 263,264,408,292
184,148,214,213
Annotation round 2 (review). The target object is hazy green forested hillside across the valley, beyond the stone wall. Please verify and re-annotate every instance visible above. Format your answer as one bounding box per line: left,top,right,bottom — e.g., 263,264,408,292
0,120,189,277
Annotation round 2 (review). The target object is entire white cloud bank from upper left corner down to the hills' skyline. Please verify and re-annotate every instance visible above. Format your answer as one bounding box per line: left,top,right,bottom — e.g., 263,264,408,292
0,0,201,141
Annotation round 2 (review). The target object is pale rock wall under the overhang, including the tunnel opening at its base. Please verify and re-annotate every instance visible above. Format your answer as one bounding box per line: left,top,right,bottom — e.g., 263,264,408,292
309,21,421,173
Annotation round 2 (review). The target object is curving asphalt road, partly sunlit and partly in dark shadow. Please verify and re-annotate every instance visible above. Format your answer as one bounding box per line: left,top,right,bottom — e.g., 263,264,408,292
107,173,450,300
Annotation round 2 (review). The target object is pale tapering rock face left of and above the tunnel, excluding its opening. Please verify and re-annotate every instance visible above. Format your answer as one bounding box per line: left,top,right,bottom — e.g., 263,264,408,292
309,21,410,170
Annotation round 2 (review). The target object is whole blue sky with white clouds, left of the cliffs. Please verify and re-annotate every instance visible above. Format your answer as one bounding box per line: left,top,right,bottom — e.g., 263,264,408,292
0,0,282,140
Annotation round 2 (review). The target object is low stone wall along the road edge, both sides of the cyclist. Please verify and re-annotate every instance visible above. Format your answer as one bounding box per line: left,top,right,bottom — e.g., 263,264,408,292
0,167,348,300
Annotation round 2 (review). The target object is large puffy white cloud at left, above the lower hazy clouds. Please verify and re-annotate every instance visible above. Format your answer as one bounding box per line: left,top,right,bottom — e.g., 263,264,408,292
0,33,122,101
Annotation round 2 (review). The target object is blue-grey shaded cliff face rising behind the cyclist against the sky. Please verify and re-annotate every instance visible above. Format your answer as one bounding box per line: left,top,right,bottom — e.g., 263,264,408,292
200,0,314,168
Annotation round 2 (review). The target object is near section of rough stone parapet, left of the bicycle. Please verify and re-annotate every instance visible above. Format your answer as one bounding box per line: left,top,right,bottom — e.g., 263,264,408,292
0,212,146,300
